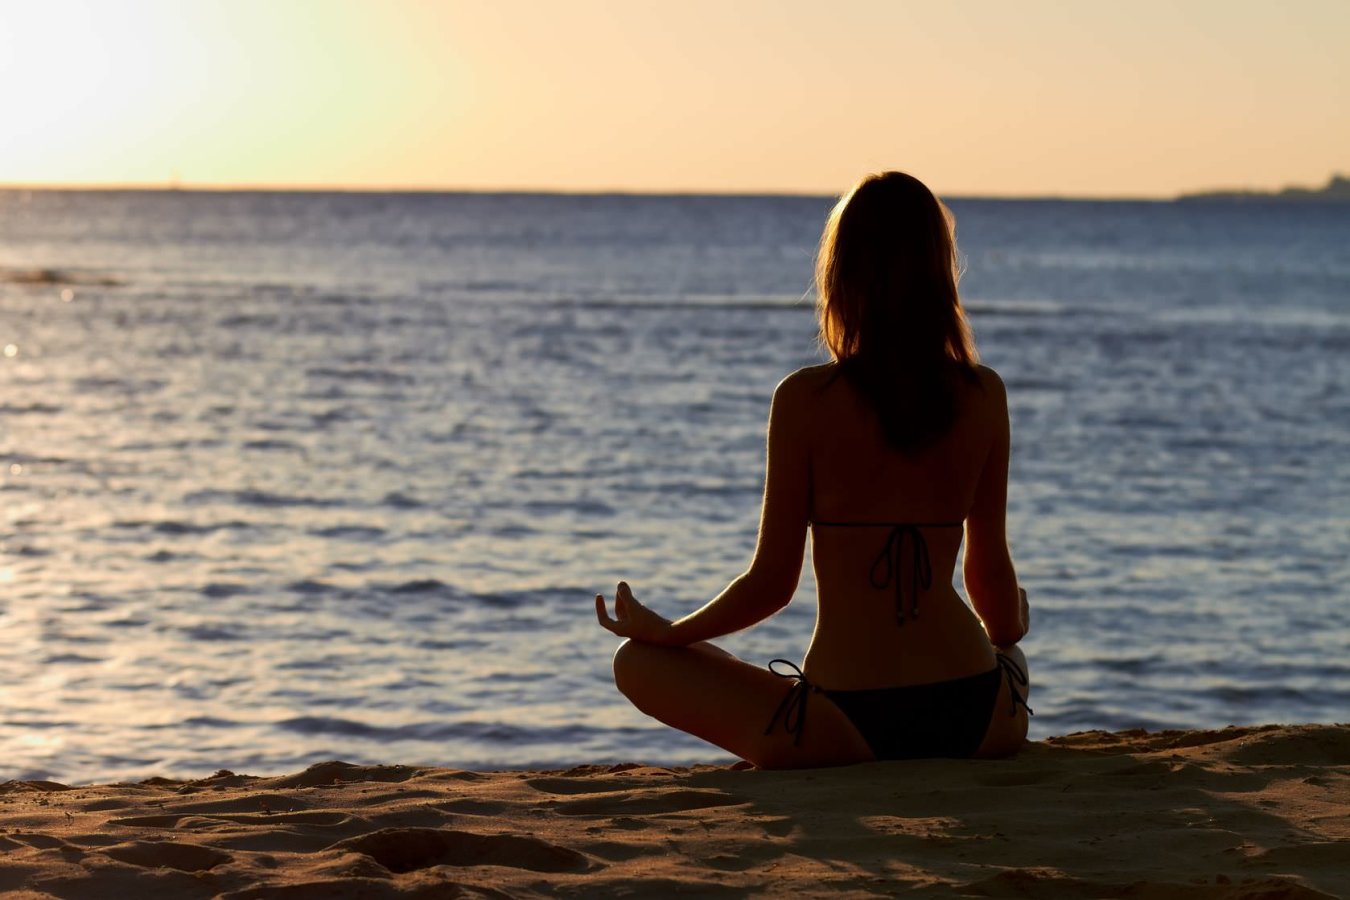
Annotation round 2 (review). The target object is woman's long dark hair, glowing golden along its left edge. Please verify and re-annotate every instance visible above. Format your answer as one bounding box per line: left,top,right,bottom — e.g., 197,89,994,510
815,171,979,453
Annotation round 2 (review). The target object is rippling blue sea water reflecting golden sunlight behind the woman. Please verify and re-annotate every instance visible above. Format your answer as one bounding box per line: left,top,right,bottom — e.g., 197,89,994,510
0,192,1350,781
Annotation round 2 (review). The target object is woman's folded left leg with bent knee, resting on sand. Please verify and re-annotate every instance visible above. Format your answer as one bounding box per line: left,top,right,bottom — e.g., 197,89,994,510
614,641,873,769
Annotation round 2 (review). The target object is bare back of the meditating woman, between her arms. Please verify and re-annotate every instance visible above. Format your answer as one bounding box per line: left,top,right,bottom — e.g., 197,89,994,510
792,366,1007,690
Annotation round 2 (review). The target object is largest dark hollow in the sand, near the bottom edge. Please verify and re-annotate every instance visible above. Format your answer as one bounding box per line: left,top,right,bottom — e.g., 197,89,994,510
329,828,591,873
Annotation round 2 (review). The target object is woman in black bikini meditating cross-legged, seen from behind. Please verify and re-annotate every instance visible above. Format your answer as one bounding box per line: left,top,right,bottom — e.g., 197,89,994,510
595,171,1029,768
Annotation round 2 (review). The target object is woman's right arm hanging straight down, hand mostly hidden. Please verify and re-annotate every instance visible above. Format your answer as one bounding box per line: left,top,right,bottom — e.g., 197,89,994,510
963,368,1030,646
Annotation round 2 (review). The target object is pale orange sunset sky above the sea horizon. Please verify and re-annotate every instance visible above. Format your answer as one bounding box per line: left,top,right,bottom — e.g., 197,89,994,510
0,0,1350,197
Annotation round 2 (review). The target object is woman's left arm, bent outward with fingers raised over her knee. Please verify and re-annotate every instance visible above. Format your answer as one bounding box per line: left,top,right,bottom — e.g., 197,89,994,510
595,372,811,646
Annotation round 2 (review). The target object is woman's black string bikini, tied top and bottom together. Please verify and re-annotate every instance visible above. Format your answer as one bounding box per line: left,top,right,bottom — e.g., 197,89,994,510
764,522,1031,760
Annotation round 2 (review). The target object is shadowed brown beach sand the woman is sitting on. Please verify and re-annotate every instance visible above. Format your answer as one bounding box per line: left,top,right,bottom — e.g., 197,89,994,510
0,726,1350,900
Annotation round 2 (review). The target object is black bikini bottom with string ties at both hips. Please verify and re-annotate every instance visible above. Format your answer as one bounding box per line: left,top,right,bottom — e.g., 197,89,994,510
764,653,1031,760
